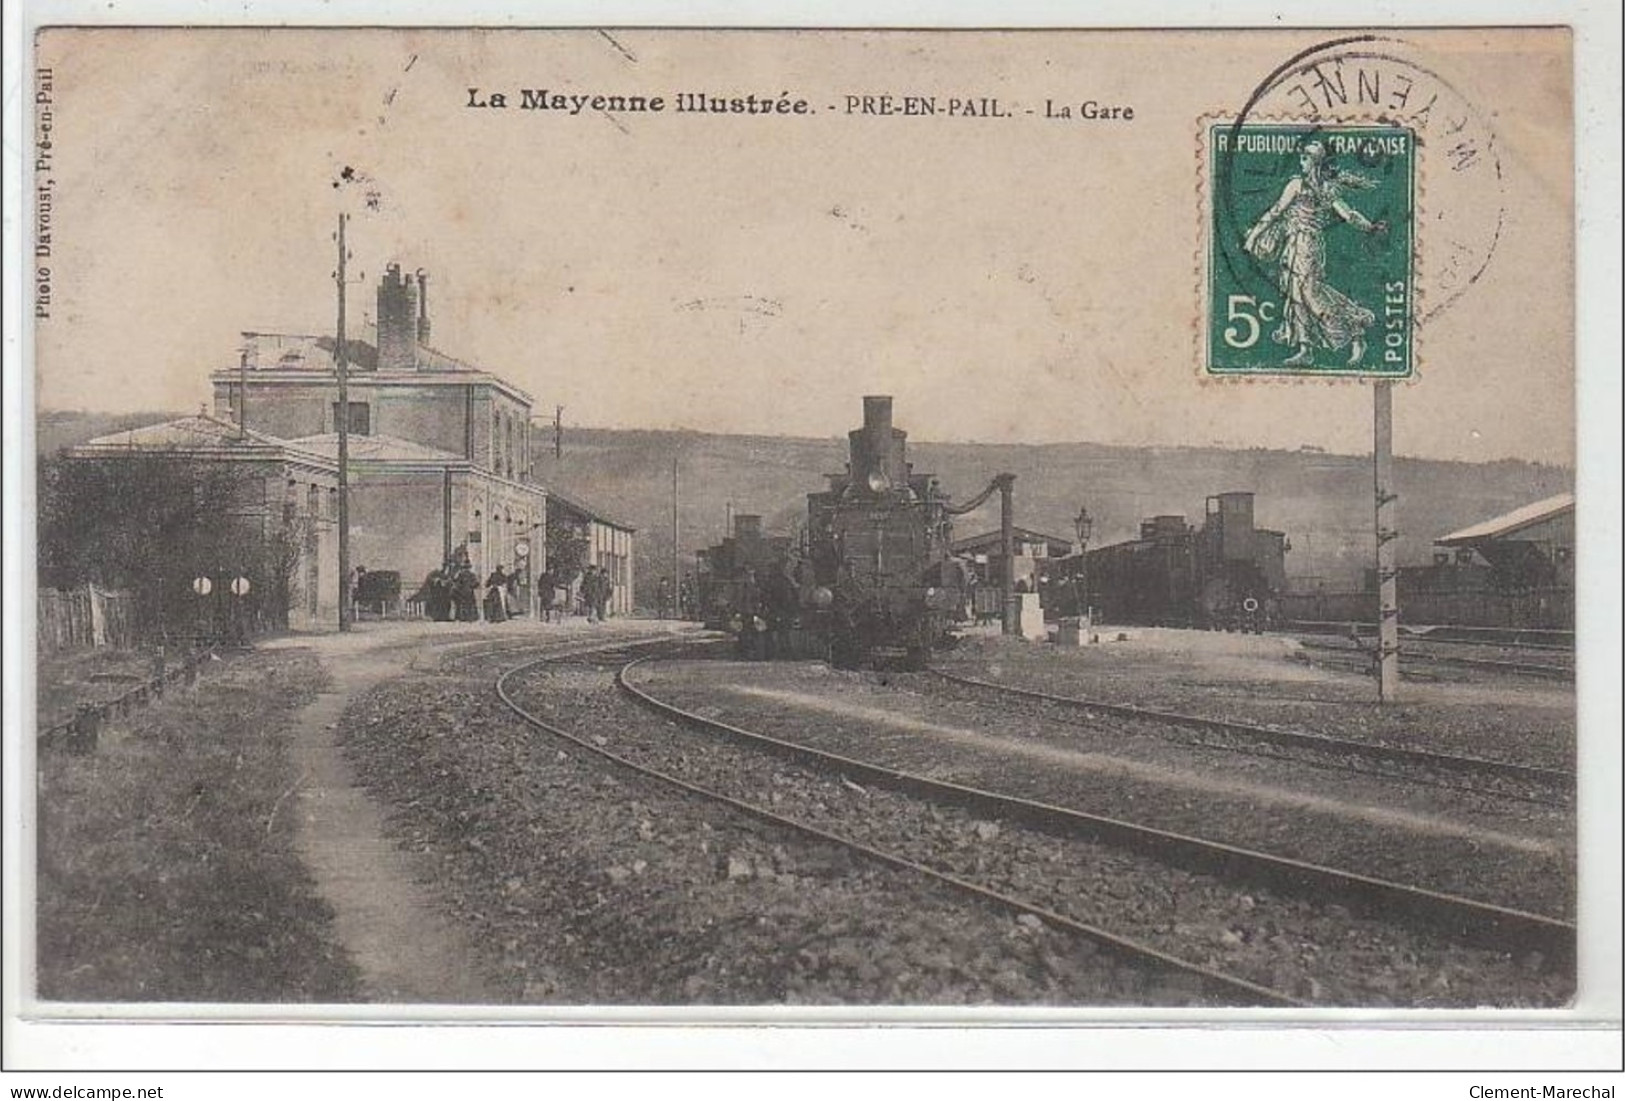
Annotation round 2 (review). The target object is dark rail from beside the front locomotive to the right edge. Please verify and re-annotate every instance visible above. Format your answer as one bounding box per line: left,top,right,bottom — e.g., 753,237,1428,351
931,669,1576,798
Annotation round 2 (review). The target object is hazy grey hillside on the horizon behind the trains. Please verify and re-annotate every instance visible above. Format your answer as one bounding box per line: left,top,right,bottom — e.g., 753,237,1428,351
36,412,1573,604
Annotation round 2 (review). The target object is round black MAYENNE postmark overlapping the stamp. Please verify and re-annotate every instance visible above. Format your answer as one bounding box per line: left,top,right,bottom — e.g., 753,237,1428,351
1212,34,1506,326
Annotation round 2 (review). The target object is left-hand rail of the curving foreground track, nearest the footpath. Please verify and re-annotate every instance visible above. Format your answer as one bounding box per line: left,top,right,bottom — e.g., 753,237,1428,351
496,646,1308,1007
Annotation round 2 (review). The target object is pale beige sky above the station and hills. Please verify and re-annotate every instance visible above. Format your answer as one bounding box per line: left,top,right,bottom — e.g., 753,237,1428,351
36,29,1575,464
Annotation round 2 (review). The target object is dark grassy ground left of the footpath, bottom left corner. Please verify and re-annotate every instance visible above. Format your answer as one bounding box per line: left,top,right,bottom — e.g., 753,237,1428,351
37,651,358,1002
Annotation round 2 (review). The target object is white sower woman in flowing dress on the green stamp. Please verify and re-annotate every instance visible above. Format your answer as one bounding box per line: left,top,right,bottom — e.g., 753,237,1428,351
1243,141,1388,367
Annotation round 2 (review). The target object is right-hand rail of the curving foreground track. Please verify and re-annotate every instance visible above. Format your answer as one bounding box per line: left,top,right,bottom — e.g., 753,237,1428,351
616,659,1576,961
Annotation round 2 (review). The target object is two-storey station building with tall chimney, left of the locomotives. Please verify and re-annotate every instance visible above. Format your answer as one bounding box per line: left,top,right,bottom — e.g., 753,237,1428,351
66,263,634,627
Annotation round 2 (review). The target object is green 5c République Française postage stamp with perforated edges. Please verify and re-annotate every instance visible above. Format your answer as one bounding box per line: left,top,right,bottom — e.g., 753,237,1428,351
1204,122,1415,378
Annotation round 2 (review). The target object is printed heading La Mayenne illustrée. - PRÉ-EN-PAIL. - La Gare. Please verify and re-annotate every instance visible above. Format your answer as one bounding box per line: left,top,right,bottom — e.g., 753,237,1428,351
463,88,1134,122
